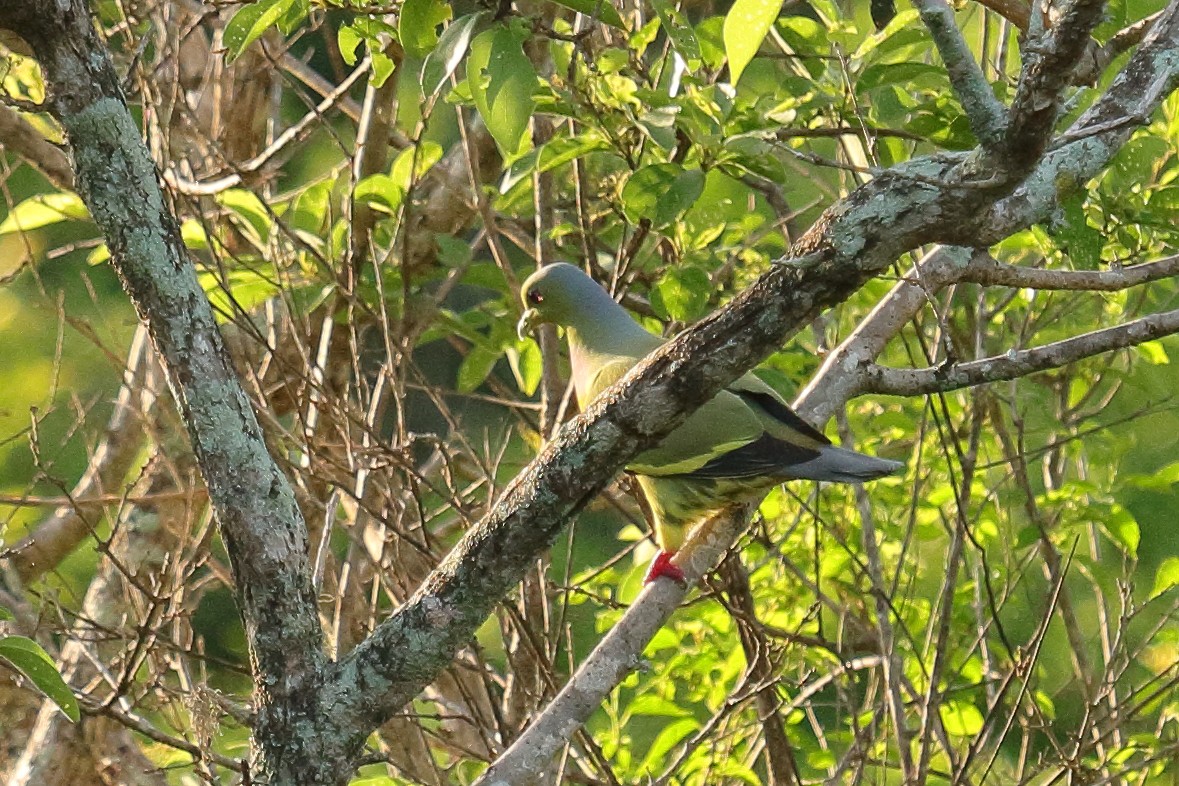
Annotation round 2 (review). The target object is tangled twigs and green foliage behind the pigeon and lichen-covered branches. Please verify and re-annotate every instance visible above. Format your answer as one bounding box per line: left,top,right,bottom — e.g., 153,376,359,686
0,0,1179,786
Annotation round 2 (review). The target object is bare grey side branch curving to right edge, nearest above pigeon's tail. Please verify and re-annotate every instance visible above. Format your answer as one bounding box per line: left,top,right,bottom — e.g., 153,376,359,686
863,309,1179,396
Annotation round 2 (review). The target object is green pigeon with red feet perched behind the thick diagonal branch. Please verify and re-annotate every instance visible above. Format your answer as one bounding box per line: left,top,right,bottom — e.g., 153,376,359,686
518,263,904,582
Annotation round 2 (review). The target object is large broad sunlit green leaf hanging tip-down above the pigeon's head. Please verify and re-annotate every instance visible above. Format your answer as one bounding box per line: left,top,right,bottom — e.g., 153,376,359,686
467,25,539,158
